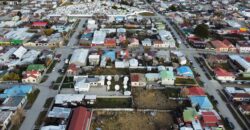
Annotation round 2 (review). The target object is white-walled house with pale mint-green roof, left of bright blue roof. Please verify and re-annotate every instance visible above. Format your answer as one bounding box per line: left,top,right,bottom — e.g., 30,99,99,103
160,67,175,85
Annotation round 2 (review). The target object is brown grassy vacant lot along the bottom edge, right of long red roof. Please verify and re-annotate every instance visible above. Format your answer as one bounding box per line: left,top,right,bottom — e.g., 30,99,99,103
91,111,173,130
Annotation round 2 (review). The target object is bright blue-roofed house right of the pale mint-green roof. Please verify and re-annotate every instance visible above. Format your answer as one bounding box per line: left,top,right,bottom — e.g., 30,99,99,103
176,66,194,78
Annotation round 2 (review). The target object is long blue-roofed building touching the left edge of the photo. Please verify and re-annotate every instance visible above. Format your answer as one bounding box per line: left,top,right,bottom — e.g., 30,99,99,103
0,85,33,98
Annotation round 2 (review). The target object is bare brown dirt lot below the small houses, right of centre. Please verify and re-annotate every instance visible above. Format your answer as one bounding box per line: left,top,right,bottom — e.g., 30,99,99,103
132,88,180,110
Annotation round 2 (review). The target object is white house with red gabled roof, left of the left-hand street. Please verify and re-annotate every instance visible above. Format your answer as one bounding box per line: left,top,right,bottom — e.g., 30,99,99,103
22,70,41,83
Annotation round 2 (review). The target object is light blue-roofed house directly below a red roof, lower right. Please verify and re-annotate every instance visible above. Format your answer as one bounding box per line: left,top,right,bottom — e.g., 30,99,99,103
189,96,213,110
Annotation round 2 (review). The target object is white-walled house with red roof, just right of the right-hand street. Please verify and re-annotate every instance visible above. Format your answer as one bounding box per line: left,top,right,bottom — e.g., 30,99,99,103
214,67,235,82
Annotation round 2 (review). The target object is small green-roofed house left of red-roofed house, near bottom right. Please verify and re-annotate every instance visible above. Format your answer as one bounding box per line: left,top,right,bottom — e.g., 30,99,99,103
183,107,198,122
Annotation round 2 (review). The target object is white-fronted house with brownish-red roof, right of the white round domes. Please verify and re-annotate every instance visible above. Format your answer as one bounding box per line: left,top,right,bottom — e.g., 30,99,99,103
130,73,147,87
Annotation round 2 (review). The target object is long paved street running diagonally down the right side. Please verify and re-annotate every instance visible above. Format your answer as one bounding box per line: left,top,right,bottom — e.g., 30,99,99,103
145,0,242,130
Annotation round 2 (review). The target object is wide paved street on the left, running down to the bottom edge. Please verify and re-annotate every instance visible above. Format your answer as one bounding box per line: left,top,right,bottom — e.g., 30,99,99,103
20,19,85,130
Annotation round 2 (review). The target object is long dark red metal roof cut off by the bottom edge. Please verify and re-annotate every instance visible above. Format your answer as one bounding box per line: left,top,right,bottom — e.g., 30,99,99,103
67,107,91,130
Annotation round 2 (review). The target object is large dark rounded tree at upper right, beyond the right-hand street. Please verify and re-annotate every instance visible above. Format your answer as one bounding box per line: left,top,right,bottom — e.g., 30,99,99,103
194,24,209,38
